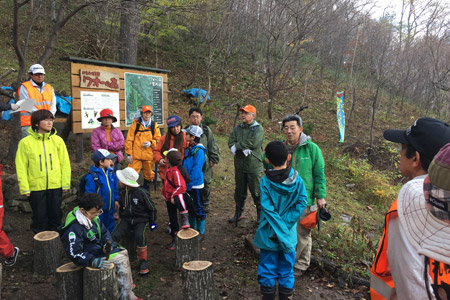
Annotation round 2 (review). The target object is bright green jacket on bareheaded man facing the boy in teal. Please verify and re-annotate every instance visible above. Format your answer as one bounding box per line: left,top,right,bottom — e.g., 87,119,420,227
263,133,327,206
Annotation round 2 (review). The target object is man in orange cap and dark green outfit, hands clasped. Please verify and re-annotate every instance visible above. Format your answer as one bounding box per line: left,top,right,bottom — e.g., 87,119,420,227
228,105,264,223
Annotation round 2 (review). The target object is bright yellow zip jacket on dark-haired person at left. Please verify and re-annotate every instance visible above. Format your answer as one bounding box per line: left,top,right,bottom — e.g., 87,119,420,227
16,127,71,195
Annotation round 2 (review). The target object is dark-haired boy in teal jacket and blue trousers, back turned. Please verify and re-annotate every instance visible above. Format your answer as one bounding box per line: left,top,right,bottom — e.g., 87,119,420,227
253,141,308,300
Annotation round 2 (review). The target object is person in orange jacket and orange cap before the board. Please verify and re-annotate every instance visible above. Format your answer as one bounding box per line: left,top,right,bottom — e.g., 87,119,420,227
125,105,161,190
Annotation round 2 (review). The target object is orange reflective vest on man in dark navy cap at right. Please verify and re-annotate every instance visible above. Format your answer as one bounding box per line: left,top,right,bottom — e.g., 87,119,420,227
370,200,398,300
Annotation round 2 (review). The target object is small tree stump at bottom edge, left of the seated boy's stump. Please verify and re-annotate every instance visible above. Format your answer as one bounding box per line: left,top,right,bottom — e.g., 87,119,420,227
56,262,83,300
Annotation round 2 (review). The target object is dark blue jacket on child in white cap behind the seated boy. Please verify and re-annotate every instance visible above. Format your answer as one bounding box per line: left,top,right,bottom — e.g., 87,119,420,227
86,166,119,212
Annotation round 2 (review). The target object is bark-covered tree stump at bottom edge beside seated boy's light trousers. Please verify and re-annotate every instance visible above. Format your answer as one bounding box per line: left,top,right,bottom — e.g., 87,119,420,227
83,264,120,300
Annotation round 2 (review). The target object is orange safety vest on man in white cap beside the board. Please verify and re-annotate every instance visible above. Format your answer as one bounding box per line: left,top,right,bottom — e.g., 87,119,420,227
20,81,53,127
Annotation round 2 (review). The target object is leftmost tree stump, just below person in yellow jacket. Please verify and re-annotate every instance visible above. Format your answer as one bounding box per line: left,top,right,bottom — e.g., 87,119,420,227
33,231,61,275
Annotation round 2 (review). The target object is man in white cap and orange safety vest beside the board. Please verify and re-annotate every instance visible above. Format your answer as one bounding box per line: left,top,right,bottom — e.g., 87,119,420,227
19,64,56,137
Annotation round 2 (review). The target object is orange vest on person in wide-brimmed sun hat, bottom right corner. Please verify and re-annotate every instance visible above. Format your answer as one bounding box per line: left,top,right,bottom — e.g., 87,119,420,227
427,258,450,300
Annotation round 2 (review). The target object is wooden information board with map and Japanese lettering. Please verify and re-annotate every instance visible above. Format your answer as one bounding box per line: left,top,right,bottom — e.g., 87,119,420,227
67,57,169,134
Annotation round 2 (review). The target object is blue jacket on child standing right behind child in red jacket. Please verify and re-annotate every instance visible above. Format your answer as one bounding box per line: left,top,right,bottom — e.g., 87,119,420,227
183,144,206,191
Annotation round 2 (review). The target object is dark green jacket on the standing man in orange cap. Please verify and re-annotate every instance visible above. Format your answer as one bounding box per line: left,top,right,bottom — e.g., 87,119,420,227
228,121,264,173
